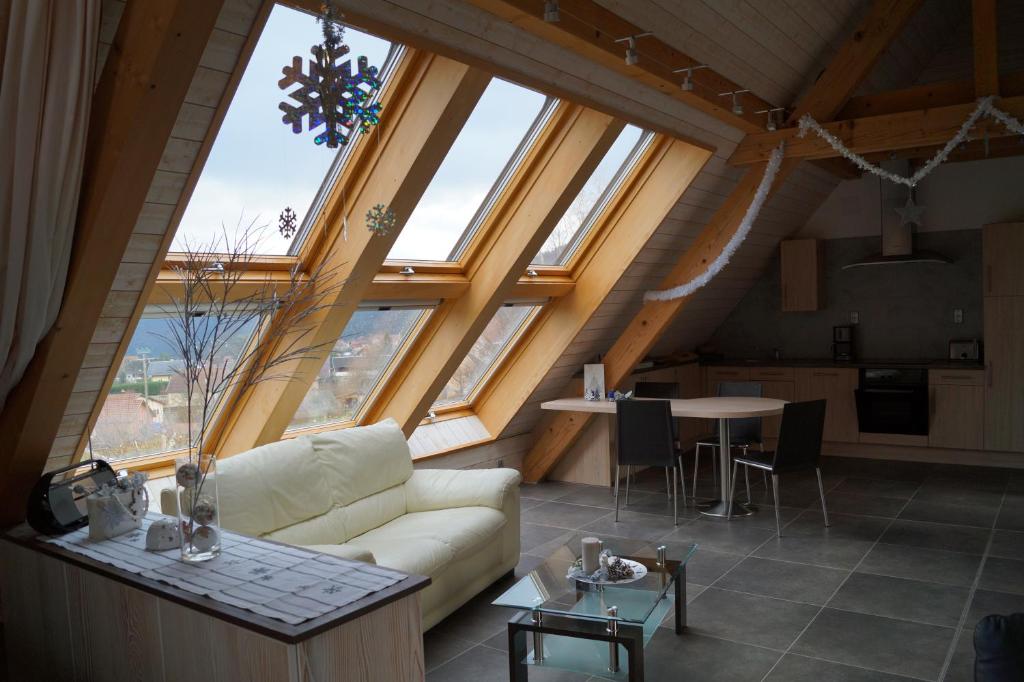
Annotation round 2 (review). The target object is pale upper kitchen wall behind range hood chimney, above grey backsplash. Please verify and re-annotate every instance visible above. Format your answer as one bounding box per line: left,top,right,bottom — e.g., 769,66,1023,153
800,156,1024,239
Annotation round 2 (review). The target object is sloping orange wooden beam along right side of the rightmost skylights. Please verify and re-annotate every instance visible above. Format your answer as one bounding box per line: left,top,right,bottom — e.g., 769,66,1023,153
474,135,711,436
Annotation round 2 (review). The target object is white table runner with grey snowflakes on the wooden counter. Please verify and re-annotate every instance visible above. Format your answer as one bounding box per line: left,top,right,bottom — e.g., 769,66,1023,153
45,513,407,625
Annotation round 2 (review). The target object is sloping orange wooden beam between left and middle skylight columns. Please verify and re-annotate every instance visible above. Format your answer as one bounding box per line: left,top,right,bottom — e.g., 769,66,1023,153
211,52,490,456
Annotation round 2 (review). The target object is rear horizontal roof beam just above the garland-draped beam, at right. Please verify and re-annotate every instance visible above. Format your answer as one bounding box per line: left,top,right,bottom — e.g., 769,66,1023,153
836,71,1024,121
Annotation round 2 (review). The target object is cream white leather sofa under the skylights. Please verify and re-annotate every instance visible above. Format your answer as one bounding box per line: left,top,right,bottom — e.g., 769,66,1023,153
161,419,520,630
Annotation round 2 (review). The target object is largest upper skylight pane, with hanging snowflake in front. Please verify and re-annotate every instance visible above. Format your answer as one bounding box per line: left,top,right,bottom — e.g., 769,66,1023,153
171,5,400,255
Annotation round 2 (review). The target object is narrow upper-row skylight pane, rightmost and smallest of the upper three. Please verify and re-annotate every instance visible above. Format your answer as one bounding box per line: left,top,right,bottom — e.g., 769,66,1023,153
532,125,653,265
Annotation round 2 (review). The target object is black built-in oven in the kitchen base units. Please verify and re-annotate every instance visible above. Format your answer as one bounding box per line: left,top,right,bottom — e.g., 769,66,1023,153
857,368,928,435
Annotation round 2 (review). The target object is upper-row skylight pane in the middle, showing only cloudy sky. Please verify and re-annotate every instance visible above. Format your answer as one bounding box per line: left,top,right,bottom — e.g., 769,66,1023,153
388,78,557,261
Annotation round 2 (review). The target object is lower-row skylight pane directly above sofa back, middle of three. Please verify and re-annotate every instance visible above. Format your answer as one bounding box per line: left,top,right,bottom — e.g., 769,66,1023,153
288,305,431,430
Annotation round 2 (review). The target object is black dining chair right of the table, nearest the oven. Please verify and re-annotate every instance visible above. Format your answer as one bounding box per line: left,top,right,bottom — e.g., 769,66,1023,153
730,400,828,538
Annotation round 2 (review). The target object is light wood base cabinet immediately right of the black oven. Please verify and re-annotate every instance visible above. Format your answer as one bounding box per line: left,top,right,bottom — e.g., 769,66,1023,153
928,370,985,450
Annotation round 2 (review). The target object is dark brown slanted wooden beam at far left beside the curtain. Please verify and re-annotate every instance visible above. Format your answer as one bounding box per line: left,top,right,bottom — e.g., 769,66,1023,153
0,0,222,525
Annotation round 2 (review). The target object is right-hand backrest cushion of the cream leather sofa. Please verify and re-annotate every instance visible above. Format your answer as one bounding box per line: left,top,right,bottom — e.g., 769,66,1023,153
309,419,413,503
